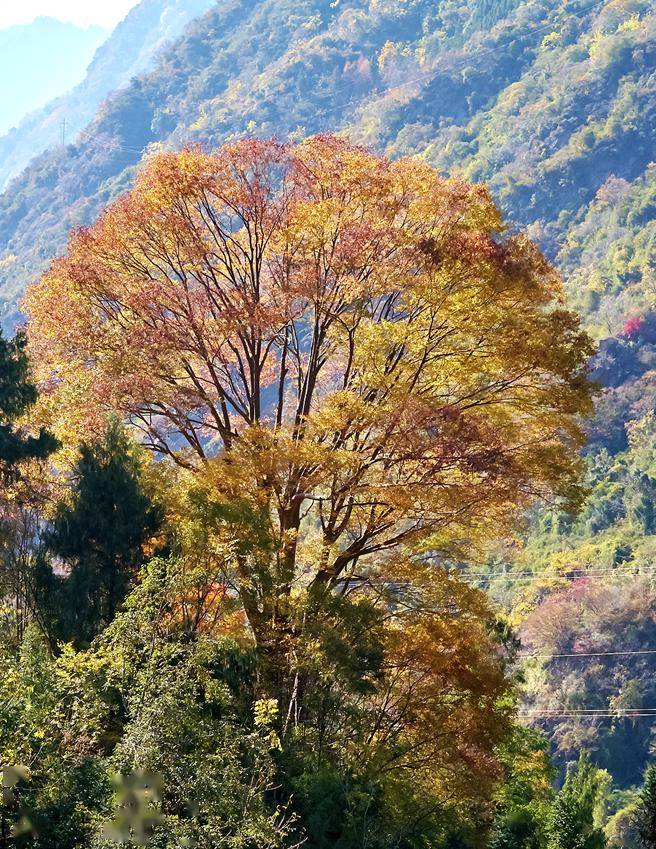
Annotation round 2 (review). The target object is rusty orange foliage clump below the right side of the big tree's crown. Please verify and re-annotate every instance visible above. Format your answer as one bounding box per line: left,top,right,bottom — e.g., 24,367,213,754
370,564,513,807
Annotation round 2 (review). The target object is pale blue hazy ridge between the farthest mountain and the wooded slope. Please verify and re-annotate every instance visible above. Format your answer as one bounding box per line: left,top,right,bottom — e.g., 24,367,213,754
0,0,215,187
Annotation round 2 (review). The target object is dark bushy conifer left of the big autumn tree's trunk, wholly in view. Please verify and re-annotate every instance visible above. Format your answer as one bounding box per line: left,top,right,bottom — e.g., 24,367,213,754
37,424,162,646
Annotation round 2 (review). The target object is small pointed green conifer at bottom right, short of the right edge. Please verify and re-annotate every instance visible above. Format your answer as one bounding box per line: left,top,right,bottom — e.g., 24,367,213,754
548,752,606,849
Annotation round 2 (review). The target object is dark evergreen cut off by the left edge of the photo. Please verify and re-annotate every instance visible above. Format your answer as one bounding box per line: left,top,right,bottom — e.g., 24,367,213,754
0,333,57,482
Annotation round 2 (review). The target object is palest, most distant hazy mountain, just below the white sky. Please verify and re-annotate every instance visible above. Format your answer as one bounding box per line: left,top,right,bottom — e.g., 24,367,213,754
0,18,108,133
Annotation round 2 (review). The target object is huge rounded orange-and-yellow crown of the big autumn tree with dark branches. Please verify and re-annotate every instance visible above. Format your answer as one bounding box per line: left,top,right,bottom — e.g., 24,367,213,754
25,136,590,661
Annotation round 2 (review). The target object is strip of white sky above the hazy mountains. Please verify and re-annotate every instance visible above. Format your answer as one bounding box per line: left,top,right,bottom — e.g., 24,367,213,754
0,0,138,29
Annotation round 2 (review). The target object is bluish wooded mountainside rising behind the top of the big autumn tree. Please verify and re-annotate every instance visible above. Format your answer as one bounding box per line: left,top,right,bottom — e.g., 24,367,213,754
5,0,656,335
